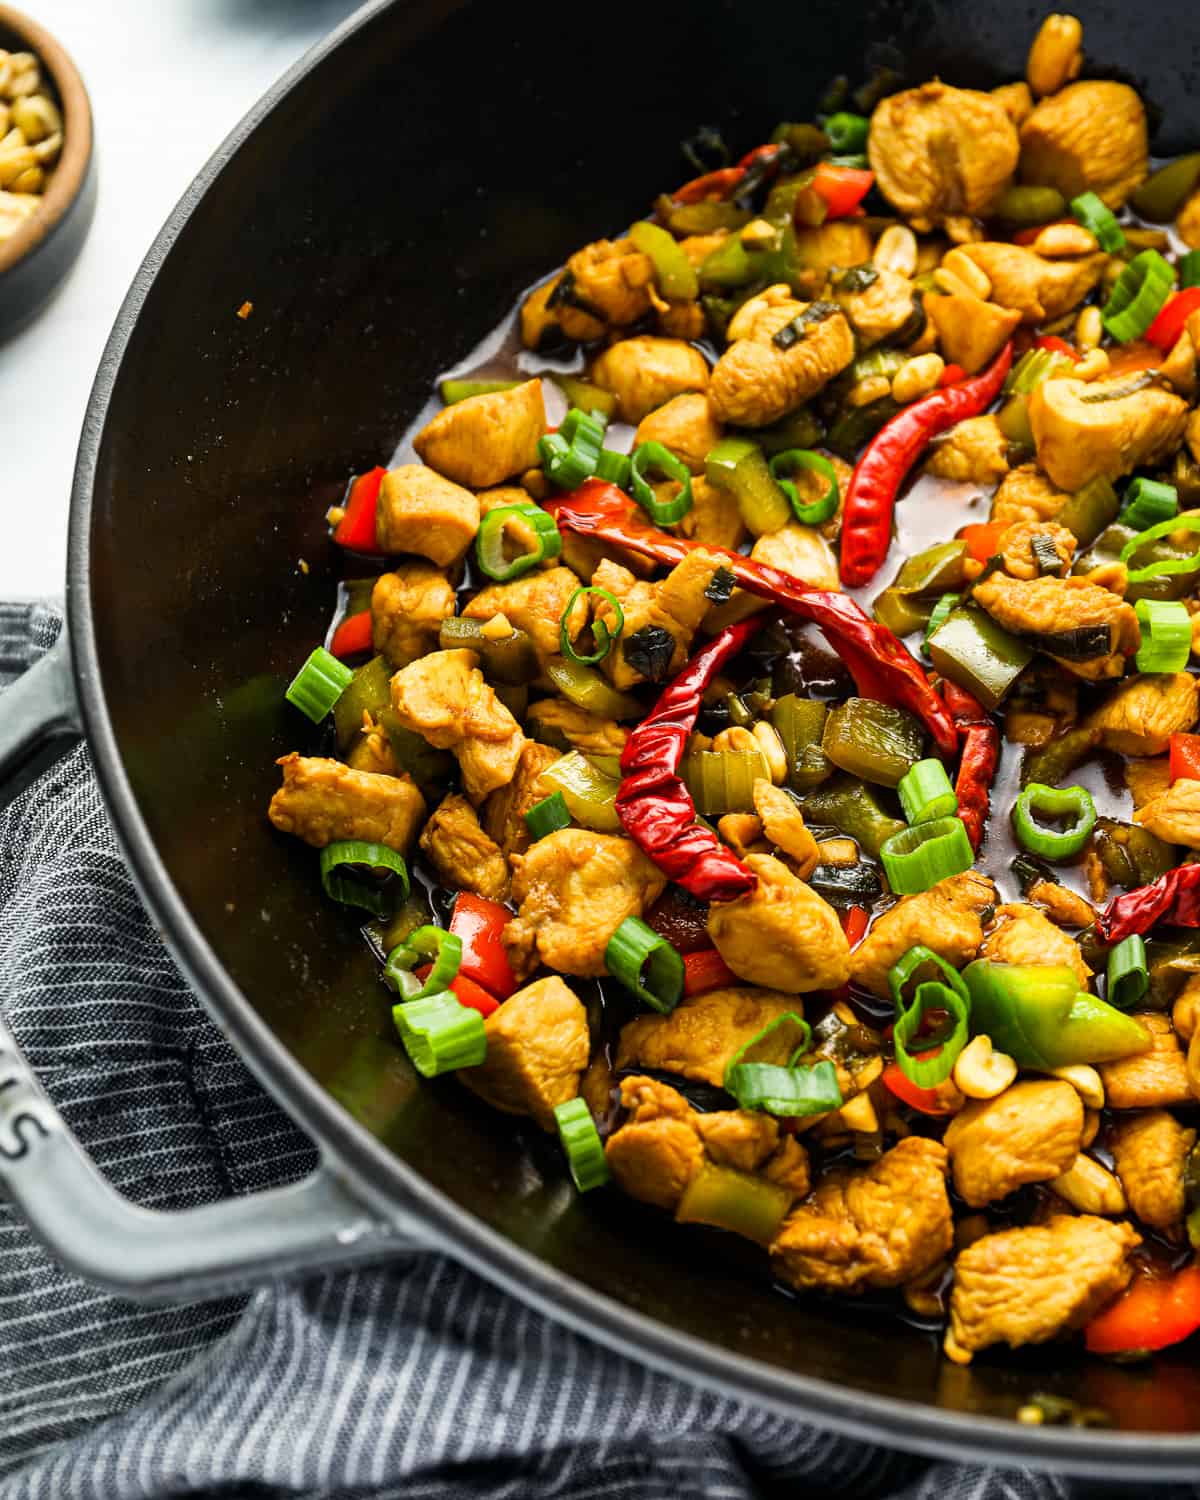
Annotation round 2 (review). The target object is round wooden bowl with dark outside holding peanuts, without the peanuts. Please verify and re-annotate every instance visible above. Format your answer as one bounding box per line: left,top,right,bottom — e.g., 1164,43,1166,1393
0,3,96,339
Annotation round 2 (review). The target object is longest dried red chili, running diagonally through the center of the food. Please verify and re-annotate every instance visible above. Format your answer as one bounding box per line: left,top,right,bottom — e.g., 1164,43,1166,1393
546,479,959,755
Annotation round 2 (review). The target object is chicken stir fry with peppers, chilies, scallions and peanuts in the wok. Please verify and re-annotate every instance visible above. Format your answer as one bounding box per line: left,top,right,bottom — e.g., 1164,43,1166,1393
270,15,1200,1364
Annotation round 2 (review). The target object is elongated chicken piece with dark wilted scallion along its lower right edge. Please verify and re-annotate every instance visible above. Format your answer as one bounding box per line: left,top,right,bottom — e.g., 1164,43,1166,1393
975,573,1142,681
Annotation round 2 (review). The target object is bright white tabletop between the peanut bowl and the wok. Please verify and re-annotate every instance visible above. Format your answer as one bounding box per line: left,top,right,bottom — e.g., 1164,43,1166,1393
0,0,363,599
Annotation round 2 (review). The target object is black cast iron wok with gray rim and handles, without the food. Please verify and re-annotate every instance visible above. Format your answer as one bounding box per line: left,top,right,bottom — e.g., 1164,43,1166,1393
0,0,1200,1479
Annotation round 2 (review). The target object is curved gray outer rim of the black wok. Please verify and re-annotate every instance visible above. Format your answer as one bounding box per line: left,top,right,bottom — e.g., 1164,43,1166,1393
66,0,1200,1481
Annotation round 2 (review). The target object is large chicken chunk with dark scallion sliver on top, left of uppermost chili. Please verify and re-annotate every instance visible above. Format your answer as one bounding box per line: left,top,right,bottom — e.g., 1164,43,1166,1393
708,285,854,428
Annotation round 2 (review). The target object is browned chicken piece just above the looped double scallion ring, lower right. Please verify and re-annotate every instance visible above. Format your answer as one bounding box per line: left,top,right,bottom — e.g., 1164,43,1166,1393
851,870,996,998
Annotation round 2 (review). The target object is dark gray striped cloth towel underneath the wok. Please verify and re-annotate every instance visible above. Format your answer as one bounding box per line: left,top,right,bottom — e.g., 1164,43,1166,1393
0,605,1194,1500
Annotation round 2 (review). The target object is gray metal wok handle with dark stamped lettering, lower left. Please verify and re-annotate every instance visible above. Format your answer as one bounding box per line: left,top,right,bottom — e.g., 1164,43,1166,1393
0,1019,432,1302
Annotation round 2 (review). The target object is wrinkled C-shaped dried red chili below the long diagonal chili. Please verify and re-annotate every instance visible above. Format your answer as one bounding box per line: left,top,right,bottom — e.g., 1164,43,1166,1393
617,618,762,902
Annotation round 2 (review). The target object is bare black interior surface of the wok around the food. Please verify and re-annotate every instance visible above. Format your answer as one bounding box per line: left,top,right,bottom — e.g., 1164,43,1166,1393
89,0,1200,1469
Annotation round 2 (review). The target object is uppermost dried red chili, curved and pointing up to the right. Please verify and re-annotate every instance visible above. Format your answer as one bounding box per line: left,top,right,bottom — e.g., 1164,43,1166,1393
842,342,1013,588
